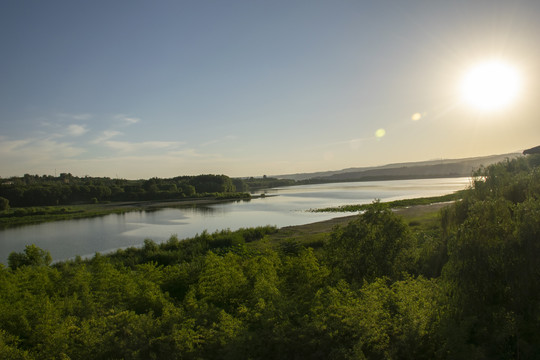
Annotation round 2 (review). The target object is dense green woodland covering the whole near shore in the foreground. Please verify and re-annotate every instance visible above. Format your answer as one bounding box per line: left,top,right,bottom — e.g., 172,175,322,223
0,155,540,359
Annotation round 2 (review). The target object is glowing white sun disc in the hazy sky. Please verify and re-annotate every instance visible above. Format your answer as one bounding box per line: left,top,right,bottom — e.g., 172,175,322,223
461,60,521,111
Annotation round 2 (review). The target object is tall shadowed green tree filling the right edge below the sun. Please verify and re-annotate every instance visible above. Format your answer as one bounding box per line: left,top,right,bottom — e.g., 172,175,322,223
443,157,540,359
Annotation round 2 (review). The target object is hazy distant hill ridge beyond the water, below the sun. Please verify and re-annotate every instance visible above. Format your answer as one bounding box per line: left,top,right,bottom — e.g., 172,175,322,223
272,153,522,182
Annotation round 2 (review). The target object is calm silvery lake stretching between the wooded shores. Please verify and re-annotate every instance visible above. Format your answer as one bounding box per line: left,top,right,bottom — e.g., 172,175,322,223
0,178,470,264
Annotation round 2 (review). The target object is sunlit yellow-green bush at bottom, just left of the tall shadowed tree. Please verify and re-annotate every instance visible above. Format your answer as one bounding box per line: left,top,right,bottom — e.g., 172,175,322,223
306,277,441,359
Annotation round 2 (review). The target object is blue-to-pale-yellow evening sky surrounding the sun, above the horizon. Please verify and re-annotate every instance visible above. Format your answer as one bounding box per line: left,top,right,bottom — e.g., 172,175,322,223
0,0,540,179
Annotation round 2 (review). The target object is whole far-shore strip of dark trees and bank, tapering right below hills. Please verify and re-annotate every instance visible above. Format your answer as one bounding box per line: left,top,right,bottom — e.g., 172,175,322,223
0,169,486,211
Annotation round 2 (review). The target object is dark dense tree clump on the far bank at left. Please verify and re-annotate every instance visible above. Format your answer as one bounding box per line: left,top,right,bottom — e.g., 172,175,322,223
0,174,247,210
